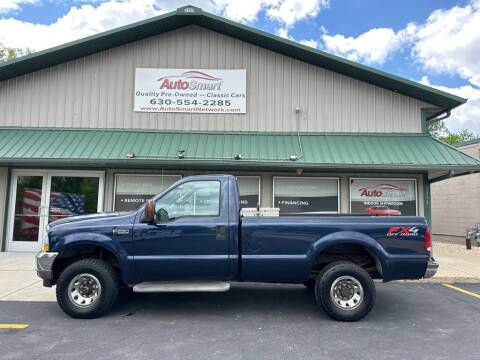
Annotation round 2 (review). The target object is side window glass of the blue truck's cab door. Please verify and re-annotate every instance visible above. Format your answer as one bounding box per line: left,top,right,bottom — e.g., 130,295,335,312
155,181,220,218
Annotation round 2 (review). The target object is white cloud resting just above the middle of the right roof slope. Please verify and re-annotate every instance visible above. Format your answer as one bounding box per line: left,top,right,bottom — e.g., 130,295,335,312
322,25,413,65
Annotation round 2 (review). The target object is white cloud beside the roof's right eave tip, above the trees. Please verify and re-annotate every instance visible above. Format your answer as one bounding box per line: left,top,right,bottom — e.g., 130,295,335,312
420,76,480,134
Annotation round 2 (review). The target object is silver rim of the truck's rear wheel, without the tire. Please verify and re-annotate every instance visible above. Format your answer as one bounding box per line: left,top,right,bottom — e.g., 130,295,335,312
330,276,364,310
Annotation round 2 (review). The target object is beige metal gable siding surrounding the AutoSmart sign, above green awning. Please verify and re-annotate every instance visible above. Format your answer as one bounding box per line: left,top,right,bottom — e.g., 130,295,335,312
0,26,429,132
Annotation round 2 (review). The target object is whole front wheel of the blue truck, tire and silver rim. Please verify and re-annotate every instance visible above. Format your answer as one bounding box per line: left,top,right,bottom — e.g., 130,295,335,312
56,259,119,319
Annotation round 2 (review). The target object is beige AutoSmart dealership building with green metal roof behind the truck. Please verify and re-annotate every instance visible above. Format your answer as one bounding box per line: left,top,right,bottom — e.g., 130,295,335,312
0,6,480,251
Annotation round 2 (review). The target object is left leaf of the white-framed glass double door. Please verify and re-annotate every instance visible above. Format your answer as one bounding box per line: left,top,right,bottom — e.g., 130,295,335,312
8,171,47,251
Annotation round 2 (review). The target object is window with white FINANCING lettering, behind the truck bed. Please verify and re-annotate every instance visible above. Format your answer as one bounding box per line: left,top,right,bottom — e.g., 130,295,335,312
273,177,339,215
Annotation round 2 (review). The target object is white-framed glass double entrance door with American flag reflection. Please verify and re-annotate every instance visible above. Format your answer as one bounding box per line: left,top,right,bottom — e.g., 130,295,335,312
8,170,104,251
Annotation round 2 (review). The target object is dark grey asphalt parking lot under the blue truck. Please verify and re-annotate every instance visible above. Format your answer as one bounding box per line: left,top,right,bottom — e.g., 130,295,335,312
0,283,480,359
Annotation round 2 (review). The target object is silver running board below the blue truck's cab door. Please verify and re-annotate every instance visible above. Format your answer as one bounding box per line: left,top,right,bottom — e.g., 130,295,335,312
133,281,230,293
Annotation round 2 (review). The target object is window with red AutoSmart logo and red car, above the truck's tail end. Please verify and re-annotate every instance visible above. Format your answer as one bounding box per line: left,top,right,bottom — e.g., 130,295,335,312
350,178,417,216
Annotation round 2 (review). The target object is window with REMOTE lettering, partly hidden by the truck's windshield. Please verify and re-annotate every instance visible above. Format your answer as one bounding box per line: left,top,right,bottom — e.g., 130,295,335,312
114,174,182,211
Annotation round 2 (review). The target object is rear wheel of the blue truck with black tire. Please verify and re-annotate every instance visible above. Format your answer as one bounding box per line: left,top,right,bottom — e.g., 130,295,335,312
315,261,376,321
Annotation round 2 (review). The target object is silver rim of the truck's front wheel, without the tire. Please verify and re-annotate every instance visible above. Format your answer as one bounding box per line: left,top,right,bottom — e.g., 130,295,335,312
68,273,102,308
